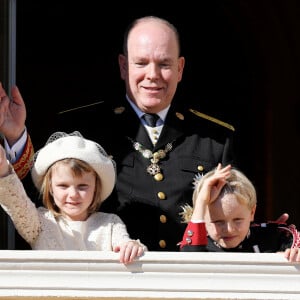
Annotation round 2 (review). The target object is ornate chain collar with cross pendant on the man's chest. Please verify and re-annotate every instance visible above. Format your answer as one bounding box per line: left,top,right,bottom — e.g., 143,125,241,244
129,138,173,176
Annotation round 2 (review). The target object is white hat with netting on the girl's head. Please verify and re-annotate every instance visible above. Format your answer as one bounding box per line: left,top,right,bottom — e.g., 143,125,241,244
31,131,116,201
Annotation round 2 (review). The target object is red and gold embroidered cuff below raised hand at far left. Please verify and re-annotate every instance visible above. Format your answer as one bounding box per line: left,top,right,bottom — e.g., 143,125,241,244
13,134,34,180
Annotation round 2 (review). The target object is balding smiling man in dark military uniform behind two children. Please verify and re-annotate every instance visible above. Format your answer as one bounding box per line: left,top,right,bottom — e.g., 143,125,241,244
56,17,234,251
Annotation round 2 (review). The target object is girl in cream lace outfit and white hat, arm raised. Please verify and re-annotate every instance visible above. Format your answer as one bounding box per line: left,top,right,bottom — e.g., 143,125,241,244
0,132,146,263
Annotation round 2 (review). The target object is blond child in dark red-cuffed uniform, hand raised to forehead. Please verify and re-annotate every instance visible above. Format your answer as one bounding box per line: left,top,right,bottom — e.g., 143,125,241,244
180,164,300,262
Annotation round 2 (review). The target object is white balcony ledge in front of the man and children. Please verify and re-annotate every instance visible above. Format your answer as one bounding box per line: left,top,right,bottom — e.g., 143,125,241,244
0,250,300,300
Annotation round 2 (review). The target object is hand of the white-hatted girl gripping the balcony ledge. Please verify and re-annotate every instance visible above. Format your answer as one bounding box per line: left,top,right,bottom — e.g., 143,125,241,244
113,240,147,264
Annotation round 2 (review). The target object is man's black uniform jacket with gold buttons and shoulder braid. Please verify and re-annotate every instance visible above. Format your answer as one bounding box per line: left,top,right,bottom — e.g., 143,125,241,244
35,101,234,251
